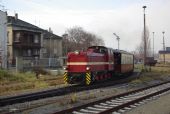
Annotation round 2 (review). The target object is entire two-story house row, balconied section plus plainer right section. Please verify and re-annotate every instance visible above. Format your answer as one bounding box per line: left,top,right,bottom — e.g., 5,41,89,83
7,14,62,67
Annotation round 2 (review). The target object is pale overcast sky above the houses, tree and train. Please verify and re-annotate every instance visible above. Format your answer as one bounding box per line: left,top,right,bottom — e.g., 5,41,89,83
0,0,170,51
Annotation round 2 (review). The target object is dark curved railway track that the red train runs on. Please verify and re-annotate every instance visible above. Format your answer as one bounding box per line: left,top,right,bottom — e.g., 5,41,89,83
0,71,138,107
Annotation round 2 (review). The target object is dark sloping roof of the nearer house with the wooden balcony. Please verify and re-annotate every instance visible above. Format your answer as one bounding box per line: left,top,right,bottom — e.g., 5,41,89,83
8,16,42,30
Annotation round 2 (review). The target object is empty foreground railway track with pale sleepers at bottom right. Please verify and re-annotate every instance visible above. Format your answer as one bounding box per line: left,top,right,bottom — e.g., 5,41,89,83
53,81,170,114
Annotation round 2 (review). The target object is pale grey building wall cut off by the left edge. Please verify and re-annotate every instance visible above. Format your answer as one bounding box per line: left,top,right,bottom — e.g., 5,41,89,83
0,10,7,68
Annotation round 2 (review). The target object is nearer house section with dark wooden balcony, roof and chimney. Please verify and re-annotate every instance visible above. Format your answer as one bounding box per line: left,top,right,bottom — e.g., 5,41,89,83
7,14,42,66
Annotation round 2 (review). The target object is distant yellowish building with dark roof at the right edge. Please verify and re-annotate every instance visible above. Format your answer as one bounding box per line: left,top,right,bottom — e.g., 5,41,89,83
159,47,170,63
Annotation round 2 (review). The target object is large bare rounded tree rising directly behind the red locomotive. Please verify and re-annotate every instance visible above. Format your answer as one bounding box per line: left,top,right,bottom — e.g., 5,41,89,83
63,27,104,54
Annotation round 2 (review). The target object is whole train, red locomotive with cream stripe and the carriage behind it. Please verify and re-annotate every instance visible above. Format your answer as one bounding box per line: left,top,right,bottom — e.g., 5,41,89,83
64,46,134,85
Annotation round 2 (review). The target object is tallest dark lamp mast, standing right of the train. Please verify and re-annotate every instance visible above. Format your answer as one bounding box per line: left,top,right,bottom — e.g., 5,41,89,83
143,6,147,68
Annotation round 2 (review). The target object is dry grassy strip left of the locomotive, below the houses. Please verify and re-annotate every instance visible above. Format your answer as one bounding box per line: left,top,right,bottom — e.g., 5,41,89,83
0,70,63,95
